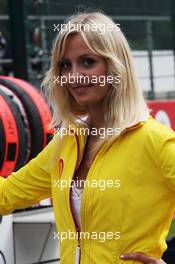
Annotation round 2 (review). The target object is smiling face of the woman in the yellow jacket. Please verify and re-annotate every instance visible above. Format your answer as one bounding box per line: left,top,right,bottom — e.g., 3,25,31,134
60,33,110,106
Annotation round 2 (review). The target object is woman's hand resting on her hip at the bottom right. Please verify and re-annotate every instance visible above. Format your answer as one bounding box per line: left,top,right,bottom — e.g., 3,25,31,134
120,252,166,264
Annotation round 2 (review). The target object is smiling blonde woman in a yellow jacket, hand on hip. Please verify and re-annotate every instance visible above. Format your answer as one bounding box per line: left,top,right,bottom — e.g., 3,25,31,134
0,12,175,264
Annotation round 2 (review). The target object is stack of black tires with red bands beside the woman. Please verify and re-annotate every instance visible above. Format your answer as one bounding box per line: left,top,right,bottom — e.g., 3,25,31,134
0,76,54,177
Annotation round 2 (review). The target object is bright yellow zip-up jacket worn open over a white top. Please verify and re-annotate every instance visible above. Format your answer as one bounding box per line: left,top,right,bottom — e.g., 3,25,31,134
0,117,175,264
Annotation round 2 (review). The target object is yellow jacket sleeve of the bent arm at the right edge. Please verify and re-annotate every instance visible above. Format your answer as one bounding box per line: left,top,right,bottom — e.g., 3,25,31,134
158,131,175,193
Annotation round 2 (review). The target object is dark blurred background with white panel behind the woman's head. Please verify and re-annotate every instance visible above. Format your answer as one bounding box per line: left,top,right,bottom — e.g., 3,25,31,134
0,0,175,99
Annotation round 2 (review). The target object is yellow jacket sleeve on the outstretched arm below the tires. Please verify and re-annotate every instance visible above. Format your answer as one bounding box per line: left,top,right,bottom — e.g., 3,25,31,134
0,135,58,215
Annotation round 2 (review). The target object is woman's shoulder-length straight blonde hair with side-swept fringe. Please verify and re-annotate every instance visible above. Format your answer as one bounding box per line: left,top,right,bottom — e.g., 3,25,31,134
42,12,149,153
